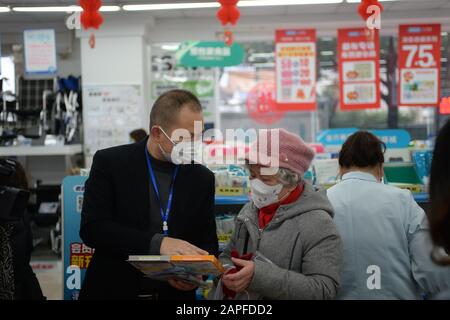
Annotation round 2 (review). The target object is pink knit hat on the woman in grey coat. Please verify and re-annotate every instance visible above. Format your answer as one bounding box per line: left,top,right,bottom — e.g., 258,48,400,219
245,129,314,177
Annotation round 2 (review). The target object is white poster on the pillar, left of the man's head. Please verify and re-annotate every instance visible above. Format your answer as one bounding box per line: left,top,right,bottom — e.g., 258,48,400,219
83,85,144,157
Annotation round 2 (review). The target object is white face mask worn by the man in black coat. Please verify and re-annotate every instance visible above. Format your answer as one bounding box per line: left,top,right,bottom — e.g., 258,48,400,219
159,127,203,164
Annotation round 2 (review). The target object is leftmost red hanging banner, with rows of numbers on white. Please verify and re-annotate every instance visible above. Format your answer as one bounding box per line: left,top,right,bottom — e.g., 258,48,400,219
275,29,317,111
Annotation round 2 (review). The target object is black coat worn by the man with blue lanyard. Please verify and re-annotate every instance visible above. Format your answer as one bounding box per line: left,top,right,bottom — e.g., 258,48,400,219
80,139,218,299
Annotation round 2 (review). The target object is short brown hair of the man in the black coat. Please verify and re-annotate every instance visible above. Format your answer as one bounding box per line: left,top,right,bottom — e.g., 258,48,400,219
150,89,202,129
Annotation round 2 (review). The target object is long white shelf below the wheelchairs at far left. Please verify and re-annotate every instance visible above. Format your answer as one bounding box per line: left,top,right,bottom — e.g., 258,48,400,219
0,144,83,157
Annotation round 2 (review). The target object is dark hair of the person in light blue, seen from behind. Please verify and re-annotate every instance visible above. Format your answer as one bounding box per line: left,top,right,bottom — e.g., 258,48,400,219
339,131,386,168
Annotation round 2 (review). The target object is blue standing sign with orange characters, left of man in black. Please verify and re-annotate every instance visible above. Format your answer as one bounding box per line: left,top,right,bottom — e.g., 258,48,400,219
62,176,89,300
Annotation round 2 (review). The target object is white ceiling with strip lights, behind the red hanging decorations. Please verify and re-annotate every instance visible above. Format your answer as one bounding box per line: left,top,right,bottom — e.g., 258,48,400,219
0,0,450,39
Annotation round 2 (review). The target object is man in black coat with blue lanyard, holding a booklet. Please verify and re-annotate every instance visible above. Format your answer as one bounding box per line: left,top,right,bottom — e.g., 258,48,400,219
80,90,218,300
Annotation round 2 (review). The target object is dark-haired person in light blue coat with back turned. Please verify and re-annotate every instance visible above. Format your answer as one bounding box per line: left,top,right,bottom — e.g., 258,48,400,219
328,131,450,299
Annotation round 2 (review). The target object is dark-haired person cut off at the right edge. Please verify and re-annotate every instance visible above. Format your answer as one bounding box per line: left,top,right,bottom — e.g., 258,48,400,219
428,120,450,299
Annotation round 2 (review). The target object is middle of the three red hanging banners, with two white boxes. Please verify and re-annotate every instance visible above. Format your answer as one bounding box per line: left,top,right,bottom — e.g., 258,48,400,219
338,28,380,110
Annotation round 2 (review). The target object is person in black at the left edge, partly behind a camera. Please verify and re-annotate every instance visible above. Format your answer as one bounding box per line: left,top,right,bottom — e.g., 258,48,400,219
0,158,45,300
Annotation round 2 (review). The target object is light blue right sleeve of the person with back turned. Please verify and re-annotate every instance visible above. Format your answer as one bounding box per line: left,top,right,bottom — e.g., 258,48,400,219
405,193,450,296
